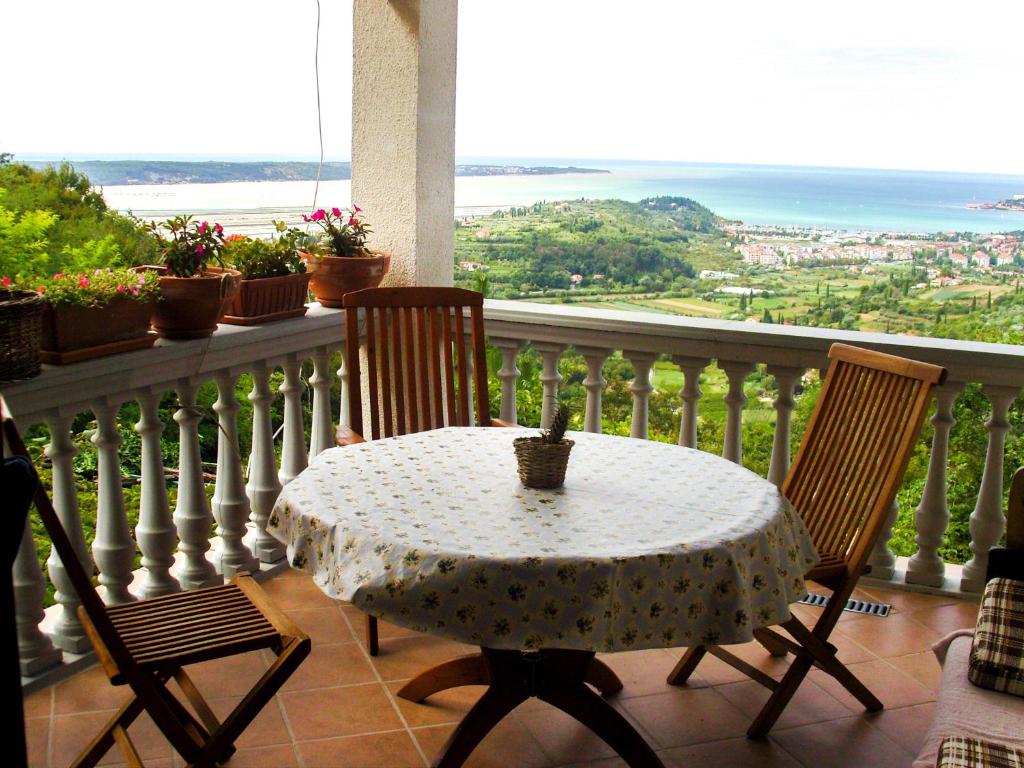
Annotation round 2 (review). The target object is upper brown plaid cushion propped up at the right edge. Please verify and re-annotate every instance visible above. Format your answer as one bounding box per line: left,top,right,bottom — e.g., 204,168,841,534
968,579,1024,696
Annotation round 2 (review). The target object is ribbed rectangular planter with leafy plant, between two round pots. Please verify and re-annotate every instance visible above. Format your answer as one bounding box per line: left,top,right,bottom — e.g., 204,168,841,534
223,221,310,326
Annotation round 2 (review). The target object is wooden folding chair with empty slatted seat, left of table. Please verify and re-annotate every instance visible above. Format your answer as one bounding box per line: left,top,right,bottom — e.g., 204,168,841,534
3,405,309,768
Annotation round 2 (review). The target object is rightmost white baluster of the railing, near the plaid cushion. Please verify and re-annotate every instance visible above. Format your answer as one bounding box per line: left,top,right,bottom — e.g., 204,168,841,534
961,384,1020,592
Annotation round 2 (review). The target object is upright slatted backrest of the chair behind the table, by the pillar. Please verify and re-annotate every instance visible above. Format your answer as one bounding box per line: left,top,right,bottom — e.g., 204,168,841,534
342,288,490,439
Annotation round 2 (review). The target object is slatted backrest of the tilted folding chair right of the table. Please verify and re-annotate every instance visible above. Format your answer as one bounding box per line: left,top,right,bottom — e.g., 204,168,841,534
782,344,946,575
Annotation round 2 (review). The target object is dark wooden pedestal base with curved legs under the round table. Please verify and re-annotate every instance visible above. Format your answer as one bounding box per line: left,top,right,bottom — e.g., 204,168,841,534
398,648,662,768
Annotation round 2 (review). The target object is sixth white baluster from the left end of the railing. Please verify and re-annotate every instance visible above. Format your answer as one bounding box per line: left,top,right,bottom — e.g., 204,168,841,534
210,371,259,579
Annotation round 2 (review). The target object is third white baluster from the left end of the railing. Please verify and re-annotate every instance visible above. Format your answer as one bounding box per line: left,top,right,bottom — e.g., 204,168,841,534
92,399,135,603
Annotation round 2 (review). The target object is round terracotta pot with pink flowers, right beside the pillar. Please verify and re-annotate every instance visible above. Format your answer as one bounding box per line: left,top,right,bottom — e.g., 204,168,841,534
302,206,391,307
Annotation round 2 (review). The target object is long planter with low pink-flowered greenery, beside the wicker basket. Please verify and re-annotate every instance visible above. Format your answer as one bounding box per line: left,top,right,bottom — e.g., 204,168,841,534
39,268,160,366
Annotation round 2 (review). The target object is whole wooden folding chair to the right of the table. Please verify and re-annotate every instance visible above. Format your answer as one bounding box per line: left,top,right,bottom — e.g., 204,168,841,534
669,344,946,738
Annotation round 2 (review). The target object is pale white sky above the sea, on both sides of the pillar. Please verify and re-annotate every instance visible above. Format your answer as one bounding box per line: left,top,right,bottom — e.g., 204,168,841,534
0,0,1024,174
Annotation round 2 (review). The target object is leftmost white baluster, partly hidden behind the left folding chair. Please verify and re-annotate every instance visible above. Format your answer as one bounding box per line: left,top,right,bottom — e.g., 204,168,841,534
13,520,61,675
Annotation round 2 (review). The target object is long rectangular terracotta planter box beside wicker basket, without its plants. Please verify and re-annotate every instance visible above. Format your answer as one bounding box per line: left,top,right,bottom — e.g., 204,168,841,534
40,296,157,366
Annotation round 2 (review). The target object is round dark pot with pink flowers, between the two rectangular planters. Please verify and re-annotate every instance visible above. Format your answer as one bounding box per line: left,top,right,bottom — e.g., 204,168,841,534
141,216,240,339
